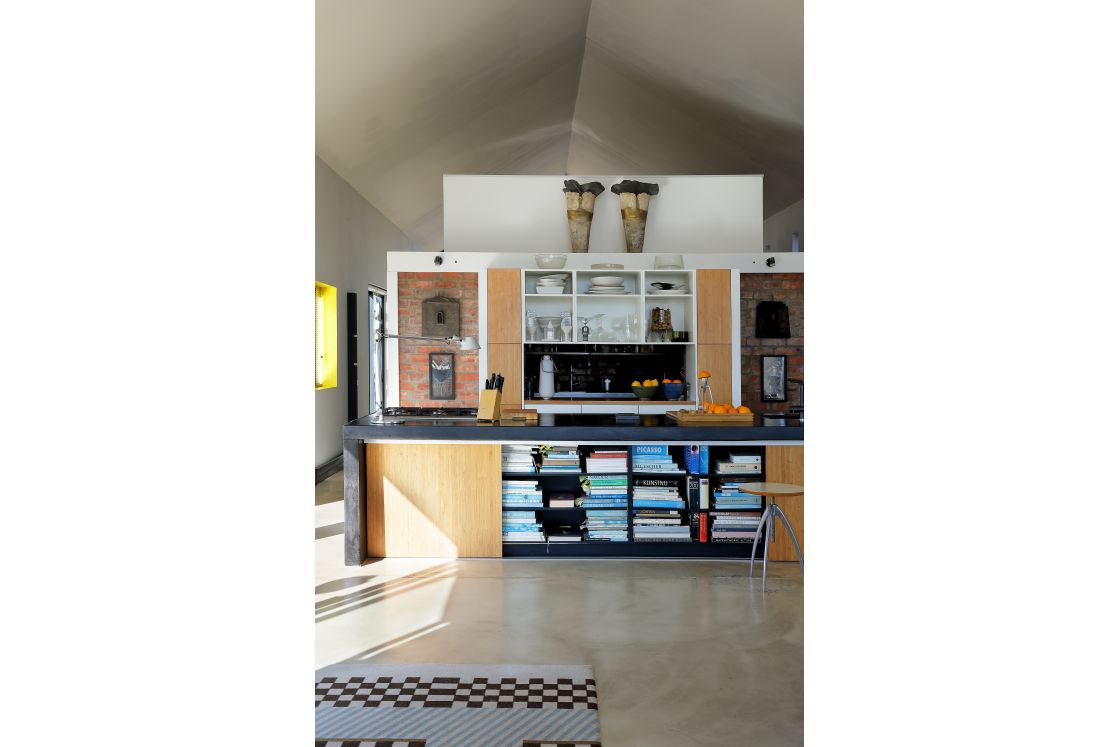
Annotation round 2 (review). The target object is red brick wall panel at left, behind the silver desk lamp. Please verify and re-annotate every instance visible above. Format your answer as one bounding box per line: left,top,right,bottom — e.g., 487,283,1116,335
396,272,478,408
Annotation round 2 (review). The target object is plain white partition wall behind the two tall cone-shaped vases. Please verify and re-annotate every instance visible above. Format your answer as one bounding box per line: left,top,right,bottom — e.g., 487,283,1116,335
444,175,763,254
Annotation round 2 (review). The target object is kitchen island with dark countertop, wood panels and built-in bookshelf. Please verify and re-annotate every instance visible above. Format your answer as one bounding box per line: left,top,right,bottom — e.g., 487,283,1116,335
343,413,804,566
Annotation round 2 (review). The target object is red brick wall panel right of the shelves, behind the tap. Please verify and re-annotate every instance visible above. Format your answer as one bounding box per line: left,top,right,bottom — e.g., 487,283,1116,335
739,272,805,412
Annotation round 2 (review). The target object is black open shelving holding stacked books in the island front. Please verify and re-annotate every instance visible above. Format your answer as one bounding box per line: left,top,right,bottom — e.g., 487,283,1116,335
502,443,766,558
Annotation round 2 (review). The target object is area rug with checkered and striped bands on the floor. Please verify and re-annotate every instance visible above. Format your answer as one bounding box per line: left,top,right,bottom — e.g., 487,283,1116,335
315,664,600,747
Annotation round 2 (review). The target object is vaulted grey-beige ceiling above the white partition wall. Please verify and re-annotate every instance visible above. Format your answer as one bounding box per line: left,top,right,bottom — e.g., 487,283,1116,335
316,0,803,250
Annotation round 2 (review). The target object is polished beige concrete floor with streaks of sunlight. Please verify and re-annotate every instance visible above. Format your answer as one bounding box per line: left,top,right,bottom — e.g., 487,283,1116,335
315,473,804,747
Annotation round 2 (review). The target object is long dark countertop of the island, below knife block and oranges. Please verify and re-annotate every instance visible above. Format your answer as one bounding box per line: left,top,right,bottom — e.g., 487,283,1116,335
343,413,805,443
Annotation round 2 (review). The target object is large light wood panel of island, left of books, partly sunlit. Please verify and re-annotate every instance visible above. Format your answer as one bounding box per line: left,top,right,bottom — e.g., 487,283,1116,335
365,443,502,558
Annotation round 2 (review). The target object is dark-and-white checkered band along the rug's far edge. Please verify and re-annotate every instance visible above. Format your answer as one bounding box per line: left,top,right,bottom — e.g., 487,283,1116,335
315,674,599,709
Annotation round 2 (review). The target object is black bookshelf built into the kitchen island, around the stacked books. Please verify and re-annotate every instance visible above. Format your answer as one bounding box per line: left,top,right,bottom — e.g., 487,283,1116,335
502,443,766,558
